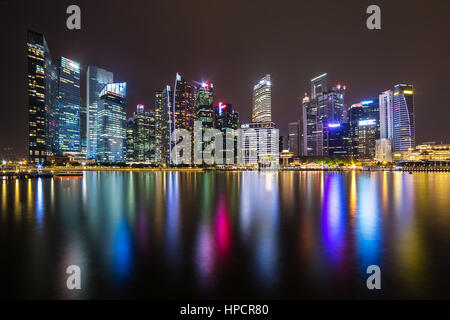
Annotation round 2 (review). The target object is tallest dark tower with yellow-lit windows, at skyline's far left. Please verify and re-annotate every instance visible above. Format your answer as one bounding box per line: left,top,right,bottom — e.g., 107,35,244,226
27,31,57,164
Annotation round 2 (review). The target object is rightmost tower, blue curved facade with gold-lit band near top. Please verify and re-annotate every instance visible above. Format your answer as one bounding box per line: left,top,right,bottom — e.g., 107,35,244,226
393,84,416,152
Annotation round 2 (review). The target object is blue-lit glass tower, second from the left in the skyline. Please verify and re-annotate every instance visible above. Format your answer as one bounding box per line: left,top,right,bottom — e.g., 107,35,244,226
56,57,81,154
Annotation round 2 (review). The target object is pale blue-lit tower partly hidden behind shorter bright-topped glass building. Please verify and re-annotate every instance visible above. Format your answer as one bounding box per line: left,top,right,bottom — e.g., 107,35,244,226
86,66,114,159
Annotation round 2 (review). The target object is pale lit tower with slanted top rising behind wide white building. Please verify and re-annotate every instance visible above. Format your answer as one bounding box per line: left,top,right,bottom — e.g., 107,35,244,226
252,74,272,122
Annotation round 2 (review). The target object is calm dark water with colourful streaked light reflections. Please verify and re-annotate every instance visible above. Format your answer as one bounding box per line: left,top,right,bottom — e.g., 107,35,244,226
0,172,450,299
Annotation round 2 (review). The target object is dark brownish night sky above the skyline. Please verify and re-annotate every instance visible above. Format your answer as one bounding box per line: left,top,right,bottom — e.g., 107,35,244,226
0,0,450,155
